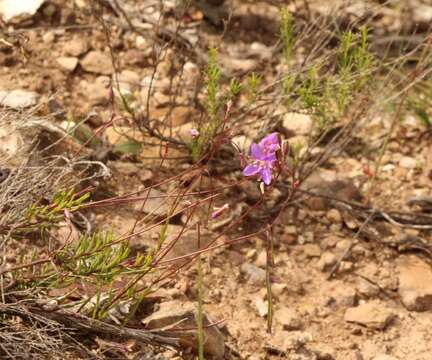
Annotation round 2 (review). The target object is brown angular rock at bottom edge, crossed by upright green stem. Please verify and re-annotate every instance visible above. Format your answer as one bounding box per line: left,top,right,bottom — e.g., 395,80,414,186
142,301,225,359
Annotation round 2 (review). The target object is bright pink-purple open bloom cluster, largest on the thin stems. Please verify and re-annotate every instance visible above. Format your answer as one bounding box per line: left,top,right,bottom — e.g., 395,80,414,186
243,133,280,185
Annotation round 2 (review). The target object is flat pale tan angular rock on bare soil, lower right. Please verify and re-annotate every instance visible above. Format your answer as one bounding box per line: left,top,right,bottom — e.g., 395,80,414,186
344,302,396,330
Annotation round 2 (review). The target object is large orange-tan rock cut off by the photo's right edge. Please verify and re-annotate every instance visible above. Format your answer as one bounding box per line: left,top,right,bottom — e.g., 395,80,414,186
397,256,432,311
